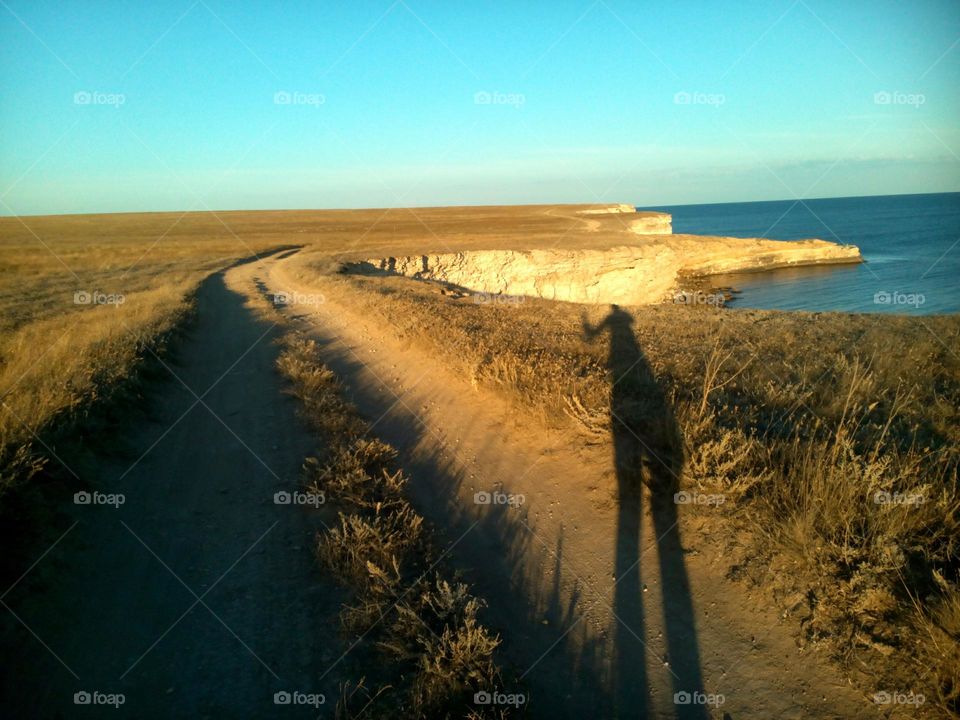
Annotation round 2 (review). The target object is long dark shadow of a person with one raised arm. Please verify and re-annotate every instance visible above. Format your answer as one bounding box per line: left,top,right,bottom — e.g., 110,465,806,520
583,305,708,718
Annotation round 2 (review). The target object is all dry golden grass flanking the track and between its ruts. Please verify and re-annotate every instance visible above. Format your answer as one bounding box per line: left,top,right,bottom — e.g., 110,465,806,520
0,206,960,715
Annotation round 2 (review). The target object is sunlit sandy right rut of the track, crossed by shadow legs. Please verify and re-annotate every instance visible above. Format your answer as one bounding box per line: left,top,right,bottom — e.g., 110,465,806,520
256,256,874,720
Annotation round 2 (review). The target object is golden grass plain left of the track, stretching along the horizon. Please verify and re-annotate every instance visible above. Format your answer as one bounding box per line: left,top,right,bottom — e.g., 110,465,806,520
0,206,656,495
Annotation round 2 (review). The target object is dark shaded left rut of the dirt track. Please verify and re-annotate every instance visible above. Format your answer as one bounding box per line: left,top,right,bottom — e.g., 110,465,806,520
0,268,342,718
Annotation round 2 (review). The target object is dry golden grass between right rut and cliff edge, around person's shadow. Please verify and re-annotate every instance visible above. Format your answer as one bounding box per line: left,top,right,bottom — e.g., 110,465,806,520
300,268,960,713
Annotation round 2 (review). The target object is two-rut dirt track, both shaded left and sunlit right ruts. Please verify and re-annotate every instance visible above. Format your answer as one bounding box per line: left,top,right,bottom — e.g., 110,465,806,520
0,252,872,720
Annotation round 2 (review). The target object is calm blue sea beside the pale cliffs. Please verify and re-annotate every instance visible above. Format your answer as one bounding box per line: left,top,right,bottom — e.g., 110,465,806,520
643,193,960,314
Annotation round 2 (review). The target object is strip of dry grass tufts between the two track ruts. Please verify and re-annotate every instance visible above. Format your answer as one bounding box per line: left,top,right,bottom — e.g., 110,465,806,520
278,334,506,718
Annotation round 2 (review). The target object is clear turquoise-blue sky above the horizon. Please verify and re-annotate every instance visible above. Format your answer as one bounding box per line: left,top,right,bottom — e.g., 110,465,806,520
0,0,960,215
